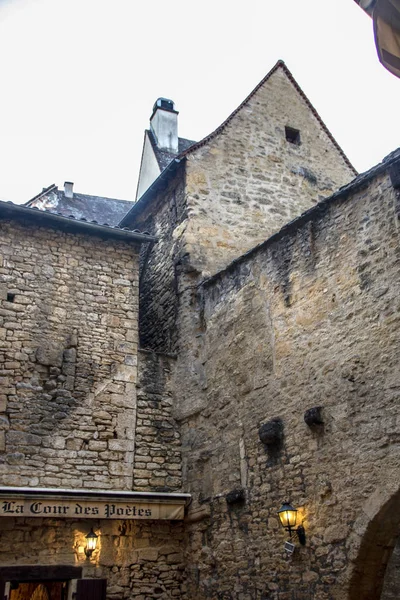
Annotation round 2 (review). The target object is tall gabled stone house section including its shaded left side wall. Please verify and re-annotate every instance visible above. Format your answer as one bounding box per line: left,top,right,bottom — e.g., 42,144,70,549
126,63,355,360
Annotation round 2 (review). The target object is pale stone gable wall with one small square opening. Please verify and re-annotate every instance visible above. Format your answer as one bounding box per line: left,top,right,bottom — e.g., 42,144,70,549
185,67,355,274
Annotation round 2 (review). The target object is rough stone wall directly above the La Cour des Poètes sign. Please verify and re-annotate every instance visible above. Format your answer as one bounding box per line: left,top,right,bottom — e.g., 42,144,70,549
0,221,139,489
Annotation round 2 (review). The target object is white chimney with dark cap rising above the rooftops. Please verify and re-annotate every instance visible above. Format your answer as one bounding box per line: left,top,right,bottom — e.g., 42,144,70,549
150,98,179,154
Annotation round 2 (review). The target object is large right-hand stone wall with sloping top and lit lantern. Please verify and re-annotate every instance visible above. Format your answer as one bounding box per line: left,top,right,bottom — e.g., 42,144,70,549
175,170,400,600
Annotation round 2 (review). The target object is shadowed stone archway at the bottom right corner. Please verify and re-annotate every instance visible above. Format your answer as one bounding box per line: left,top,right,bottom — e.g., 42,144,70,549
348,478,400,600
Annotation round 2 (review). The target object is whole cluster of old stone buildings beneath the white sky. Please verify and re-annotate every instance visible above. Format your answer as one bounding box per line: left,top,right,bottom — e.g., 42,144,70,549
0,61,400,600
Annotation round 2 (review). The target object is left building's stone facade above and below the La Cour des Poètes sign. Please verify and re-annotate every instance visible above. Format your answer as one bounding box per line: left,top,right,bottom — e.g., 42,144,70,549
0,208,184,600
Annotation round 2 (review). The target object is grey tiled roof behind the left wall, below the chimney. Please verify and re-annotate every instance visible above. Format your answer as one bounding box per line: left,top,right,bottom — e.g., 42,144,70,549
25,185,133,227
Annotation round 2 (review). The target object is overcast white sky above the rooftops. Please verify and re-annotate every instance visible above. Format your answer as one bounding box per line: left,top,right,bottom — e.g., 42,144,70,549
0,0,400,202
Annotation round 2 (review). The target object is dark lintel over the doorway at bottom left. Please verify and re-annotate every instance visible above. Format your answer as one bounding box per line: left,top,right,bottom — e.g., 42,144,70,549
0,565,82,599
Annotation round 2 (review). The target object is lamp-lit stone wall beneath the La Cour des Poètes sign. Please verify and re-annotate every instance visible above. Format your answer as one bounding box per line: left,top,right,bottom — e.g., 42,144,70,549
0,518,185,600
